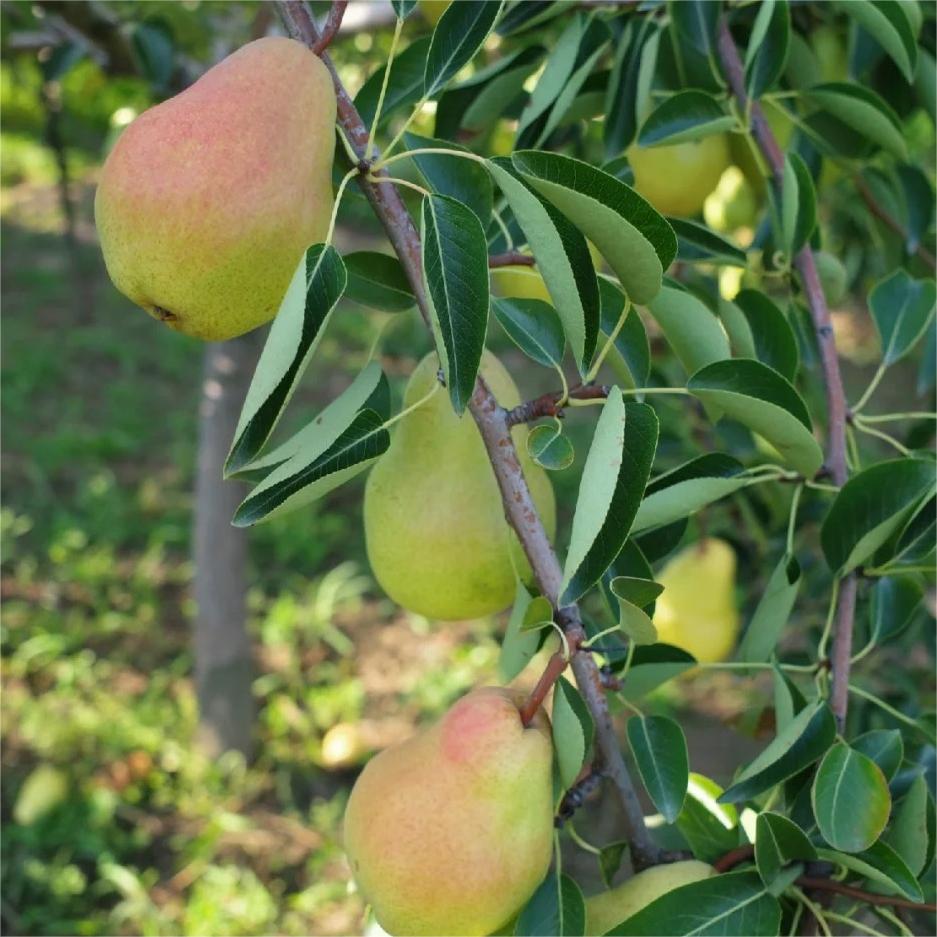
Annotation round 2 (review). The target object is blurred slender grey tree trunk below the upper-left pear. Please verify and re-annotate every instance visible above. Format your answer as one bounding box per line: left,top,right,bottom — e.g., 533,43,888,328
195,332,263,757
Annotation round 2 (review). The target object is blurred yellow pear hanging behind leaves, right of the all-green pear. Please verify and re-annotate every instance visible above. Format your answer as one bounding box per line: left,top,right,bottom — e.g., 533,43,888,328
654,537,739,663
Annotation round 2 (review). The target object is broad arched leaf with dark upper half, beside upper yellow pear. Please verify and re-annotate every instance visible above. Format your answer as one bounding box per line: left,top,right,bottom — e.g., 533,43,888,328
513,150,677,303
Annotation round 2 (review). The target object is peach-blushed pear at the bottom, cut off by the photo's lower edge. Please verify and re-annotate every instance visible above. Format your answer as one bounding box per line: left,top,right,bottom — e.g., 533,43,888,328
345,687,553,937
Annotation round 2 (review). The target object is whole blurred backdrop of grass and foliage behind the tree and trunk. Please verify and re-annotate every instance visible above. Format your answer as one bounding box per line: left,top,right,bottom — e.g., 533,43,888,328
0,0,933,934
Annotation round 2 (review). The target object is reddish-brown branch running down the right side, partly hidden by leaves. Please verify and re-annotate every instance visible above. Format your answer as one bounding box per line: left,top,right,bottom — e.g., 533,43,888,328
717,13,857,732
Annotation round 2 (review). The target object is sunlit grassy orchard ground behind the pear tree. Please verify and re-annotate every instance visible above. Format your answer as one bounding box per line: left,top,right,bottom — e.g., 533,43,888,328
2,168,926,934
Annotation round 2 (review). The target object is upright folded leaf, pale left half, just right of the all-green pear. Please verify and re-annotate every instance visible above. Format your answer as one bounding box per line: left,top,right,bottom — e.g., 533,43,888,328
560,387,658,605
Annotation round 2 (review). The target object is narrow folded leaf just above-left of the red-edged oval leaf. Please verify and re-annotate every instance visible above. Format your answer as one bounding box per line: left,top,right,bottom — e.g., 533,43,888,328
719,701,836,803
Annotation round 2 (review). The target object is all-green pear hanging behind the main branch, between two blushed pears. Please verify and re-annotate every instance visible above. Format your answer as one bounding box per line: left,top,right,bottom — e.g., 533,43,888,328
364,351,556,620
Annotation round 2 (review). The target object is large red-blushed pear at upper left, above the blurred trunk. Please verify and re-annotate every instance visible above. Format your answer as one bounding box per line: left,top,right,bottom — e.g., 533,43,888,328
94,38,335,341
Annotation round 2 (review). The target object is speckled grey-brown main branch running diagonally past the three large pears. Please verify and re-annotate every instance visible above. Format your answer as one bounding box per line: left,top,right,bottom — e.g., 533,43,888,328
277,0,662,869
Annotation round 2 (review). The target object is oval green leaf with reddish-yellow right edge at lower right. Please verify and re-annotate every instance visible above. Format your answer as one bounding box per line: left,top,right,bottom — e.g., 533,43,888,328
811,743,891,852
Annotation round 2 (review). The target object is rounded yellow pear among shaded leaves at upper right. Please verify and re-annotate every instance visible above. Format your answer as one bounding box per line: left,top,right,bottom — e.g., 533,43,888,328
626,134,729,216
